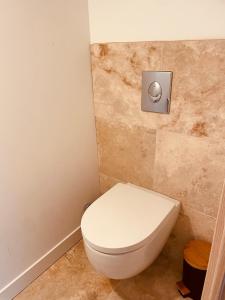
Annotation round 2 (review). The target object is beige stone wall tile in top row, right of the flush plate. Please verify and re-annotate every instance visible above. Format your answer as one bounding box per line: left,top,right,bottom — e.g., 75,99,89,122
159,40,225,139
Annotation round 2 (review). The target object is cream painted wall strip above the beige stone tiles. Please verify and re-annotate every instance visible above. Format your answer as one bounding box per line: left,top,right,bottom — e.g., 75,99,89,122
88,0,225,43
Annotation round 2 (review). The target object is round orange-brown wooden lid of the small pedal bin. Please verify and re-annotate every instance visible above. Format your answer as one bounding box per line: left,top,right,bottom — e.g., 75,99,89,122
184,240,211,271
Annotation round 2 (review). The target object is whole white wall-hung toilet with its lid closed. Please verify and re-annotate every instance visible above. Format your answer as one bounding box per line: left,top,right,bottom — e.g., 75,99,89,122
81,183,180,279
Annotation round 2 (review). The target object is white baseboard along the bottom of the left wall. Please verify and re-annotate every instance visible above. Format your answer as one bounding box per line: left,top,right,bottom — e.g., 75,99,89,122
0,226,81,300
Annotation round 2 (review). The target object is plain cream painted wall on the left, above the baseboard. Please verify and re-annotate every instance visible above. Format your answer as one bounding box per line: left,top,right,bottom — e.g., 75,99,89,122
0,0,98,299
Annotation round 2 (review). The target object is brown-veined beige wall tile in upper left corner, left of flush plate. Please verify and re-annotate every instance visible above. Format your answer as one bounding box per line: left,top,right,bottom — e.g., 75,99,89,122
92,42,162,129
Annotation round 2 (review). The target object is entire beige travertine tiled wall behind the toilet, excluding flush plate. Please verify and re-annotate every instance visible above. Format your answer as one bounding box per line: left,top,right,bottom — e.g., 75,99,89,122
91,40,225,256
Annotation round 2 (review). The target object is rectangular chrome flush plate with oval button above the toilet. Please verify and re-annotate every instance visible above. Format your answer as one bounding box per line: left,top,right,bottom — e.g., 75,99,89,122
141,71,172,114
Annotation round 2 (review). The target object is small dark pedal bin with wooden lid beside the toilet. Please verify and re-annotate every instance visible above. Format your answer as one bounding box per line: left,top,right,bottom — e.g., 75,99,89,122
177,240,211,300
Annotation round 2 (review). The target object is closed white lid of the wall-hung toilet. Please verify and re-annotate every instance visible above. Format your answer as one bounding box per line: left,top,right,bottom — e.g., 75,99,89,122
81,183,178,254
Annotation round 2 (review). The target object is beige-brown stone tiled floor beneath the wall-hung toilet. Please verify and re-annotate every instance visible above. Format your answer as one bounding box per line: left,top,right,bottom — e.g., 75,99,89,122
14,241,187,300
